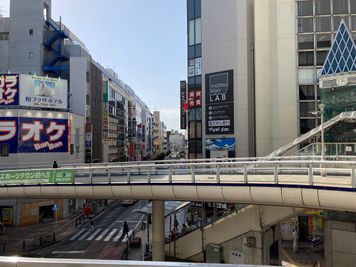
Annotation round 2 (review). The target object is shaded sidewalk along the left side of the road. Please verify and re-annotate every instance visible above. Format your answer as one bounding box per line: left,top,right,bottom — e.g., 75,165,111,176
0,202,115,256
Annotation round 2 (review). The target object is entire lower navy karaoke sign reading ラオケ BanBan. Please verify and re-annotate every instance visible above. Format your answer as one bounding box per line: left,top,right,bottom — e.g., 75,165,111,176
0,117,68,153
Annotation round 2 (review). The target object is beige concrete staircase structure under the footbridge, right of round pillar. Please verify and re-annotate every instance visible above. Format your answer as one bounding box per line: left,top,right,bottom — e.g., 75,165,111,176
166,205,303,264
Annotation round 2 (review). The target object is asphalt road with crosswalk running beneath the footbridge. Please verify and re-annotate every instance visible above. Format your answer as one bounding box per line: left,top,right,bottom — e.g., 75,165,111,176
37,201,145,260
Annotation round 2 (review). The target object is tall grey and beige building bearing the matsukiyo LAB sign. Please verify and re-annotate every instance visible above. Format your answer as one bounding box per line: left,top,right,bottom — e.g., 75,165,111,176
187,0,356,158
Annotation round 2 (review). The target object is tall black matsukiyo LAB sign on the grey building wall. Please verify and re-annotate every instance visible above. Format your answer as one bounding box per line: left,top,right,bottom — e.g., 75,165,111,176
205,70,234,135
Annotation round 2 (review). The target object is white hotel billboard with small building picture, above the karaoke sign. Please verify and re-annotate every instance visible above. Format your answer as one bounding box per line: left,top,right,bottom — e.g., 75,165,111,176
20,74,68,109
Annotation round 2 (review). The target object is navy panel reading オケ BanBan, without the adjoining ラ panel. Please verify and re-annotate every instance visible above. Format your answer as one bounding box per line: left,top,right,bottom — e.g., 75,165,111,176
18,118,68,153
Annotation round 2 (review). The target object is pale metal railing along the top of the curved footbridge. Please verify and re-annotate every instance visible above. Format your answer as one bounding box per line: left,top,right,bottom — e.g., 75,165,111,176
0,160,356,188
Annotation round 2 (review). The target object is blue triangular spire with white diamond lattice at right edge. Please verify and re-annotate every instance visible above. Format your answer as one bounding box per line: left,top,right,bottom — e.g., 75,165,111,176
321,19,356,75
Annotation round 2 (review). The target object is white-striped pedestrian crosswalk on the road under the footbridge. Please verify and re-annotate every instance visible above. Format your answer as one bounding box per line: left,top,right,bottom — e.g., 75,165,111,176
69,228,128,242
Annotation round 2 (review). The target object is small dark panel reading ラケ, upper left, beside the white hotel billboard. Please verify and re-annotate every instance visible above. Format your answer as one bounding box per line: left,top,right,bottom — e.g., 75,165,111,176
0,74,19,107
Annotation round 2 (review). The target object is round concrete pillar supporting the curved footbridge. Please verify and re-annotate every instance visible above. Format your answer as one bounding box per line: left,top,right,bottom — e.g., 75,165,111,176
152,200,165,261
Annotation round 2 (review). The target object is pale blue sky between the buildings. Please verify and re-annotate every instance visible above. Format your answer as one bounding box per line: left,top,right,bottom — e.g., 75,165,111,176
0,0,187,130
